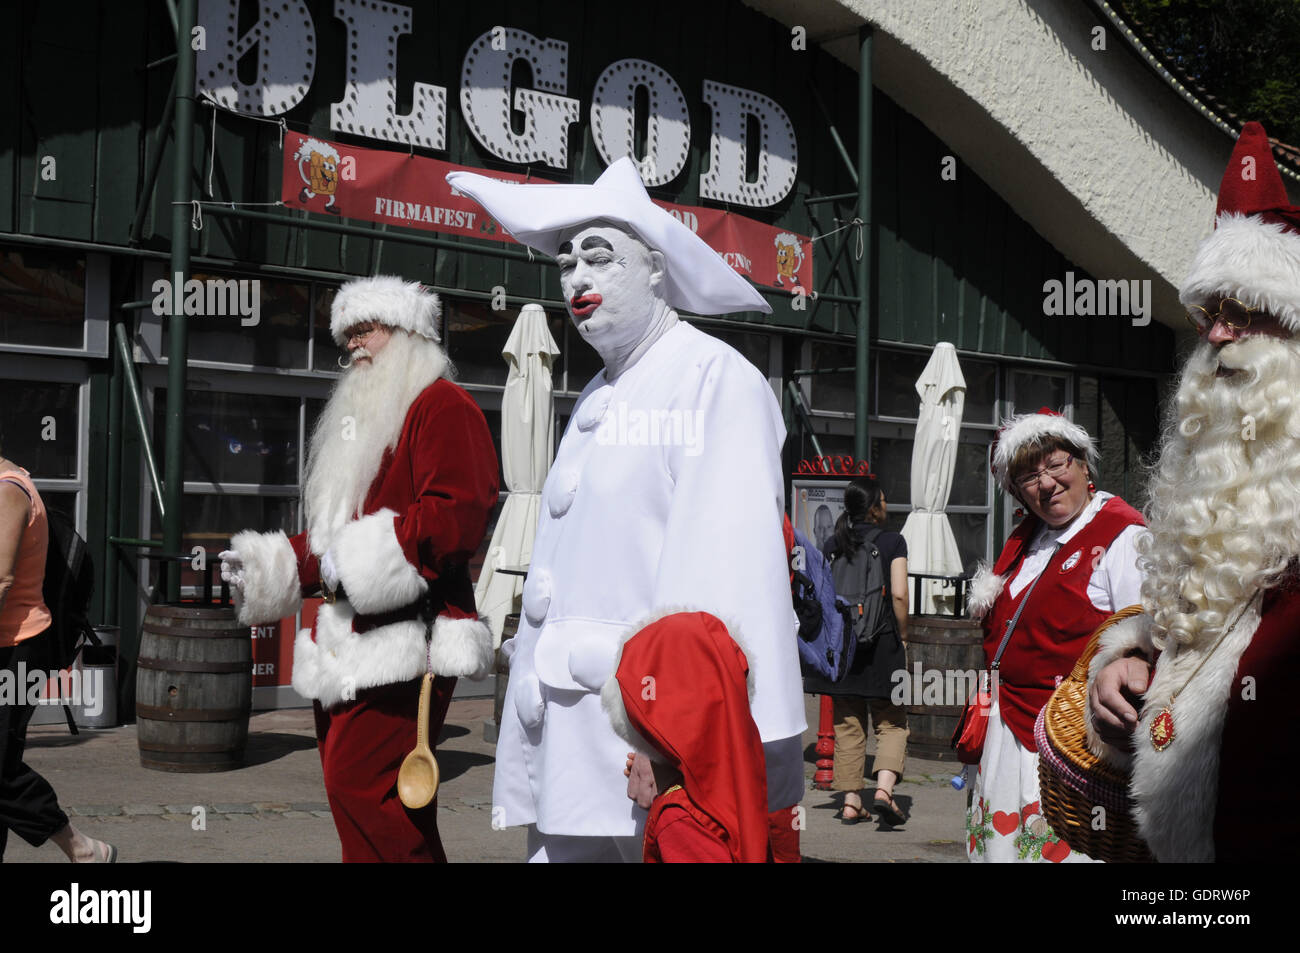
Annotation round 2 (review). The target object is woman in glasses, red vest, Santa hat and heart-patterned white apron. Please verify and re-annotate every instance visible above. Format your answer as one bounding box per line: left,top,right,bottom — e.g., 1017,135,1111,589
966,407,1143,863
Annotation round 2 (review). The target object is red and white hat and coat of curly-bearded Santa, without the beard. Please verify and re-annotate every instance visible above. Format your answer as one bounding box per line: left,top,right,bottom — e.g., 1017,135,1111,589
1088,122,1300,862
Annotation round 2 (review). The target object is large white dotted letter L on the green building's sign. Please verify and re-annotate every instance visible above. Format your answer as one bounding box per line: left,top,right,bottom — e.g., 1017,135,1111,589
329,0,447,150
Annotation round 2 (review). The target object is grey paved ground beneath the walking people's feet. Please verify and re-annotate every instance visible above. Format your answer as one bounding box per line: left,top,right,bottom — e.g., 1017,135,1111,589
4,698,965,863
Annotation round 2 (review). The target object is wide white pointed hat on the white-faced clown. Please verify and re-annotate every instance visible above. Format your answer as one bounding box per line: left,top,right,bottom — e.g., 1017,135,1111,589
447,156,772,315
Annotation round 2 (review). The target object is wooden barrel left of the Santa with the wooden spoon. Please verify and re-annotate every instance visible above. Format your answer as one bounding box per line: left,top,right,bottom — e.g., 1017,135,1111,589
135,606,252,774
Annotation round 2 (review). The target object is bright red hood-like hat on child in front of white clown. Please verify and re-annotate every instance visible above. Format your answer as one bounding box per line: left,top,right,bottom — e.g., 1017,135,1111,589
601,612,768,863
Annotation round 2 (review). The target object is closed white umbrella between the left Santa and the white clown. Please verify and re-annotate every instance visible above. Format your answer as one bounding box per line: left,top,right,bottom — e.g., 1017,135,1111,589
475,304,560,645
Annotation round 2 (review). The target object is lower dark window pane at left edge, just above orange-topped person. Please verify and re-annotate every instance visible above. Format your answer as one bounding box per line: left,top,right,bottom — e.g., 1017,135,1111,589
0,381,81,480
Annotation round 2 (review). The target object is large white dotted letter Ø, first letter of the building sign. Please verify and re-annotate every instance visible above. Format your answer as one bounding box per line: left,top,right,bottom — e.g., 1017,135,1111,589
194,0,316,116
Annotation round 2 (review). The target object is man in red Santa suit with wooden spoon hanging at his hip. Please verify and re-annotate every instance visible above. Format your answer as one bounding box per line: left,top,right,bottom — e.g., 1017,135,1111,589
224,277,498,861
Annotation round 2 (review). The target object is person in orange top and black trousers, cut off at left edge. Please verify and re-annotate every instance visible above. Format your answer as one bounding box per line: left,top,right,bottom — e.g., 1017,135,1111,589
0,456,117,863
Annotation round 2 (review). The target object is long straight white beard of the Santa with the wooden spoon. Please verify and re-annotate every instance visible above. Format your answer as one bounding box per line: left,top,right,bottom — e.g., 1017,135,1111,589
303,332,454,555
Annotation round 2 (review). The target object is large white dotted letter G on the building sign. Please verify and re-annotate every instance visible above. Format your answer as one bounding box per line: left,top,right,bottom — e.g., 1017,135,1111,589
460,27,579,169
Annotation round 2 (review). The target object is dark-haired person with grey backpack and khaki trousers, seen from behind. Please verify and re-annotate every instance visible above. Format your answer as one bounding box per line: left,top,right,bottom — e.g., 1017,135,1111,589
803,476,909,826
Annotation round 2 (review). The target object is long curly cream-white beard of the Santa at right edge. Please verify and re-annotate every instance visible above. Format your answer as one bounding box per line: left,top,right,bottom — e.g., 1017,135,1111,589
1139,335,1300,649
